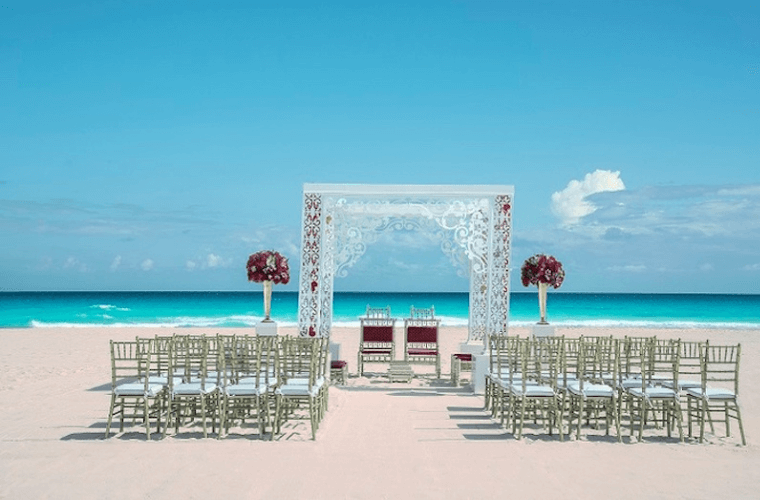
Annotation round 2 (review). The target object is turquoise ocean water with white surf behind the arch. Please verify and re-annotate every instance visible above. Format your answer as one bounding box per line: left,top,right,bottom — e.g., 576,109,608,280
0,291,760,329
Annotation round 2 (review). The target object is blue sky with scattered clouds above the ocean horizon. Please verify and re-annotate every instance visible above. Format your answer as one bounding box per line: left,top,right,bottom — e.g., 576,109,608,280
0,0,760,293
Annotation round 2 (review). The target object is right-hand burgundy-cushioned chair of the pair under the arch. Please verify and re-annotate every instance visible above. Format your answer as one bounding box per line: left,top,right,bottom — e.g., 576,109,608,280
404,306,441,378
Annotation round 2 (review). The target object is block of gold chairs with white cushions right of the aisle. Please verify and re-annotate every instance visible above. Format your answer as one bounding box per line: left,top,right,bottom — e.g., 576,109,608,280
486,335,746,445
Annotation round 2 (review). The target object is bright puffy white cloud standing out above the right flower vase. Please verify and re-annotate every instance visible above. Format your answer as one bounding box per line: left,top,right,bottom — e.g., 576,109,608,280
551,170,625,226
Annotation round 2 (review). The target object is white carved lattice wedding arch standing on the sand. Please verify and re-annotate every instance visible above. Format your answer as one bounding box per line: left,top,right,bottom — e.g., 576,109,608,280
298,184,514,342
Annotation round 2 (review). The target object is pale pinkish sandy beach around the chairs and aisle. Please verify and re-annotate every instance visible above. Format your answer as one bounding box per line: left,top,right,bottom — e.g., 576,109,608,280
0,327,760,500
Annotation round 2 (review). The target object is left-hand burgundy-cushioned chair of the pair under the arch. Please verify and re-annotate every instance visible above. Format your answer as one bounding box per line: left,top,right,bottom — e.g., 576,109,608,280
357,306,396,377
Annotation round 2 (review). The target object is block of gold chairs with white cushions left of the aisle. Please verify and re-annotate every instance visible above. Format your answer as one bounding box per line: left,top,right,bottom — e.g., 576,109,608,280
106,334,328,439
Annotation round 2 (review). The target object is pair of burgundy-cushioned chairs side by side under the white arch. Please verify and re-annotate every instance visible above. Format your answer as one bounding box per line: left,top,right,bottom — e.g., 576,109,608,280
357,306,441,378
